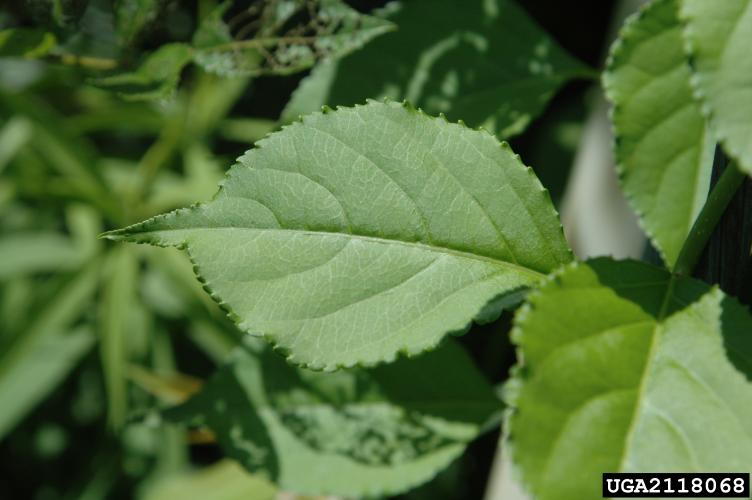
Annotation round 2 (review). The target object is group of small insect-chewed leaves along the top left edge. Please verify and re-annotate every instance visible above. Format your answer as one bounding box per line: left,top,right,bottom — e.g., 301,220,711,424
0,0,394,100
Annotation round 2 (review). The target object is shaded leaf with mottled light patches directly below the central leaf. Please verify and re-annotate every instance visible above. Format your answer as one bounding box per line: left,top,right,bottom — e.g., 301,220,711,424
165,342,501,497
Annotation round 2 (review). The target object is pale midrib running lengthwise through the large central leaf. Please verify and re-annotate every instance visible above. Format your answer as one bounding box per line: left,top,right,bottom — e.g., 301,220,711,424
123,226,546,280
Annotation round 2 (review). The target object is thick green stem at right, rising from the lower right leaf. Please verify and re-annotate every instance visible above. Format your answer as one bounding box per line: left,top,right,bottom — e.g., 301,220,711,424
674,162,745,276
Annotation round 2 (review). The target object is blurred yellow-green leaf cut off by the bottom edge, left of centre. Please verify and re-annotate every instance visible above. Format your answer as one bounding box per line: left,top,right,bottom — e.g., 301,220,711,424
144,460,278,500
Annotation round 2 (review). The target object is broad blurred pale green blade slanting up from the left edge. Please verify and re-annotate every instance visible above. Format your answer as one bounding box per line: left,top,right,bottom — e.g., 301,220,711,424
0,262,100,437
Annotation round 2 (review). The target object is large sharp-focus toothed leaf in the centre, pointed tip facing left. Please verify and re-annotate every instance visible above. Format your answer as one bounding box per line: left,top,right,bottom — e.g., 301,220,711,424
107,102,571,369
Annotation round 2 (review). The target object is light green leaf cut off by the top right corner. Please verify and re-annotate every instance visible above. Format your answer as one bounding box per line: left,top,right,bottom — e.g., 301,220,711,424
680,0,752,174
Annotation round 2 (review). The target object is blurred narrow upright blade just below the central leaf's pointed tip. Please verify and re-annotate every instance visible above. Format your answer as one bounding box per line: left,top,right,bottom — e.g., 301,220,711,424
99,248,138,428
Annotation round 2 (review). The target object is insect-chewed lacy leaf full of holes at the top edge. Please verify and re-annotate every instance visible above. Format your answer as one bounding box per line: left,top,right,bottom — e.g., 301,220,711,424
193,0,394,76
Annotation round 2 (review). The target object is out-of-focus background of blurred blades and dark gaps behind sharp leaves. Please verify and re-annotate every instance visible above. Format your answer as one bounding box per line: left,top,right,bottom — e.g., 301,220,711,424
0,0,615,500
